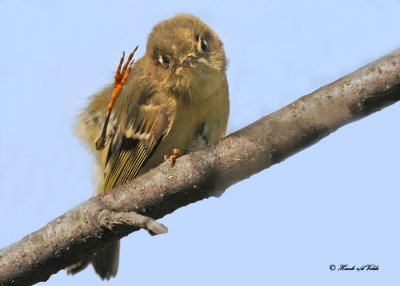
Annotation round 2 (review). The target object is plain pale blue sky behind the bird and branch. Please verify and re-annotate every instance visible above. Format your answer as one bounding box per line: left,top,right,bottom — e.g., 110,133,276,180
0,0,400,285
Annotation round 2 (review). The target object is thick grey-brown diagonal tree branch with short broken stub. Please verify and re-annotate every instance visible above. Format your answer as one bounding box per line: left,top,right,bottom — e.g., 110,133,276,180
0,50,400,285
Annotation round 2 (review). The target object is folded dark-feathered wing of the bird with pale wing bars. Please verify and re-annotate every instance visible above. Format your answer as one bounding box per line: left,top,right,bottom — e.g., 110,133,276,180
103,105,171,192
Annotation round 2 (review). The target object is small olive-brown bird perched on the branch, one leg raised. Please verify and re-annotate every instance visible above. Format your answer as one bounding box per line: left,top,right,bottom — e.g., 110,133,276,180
67,14,229,279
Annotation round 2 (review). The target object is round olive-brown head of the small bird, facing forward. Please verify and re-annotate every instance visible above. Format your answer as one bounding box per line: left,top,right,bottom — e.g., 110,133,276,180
145,14,227,103
